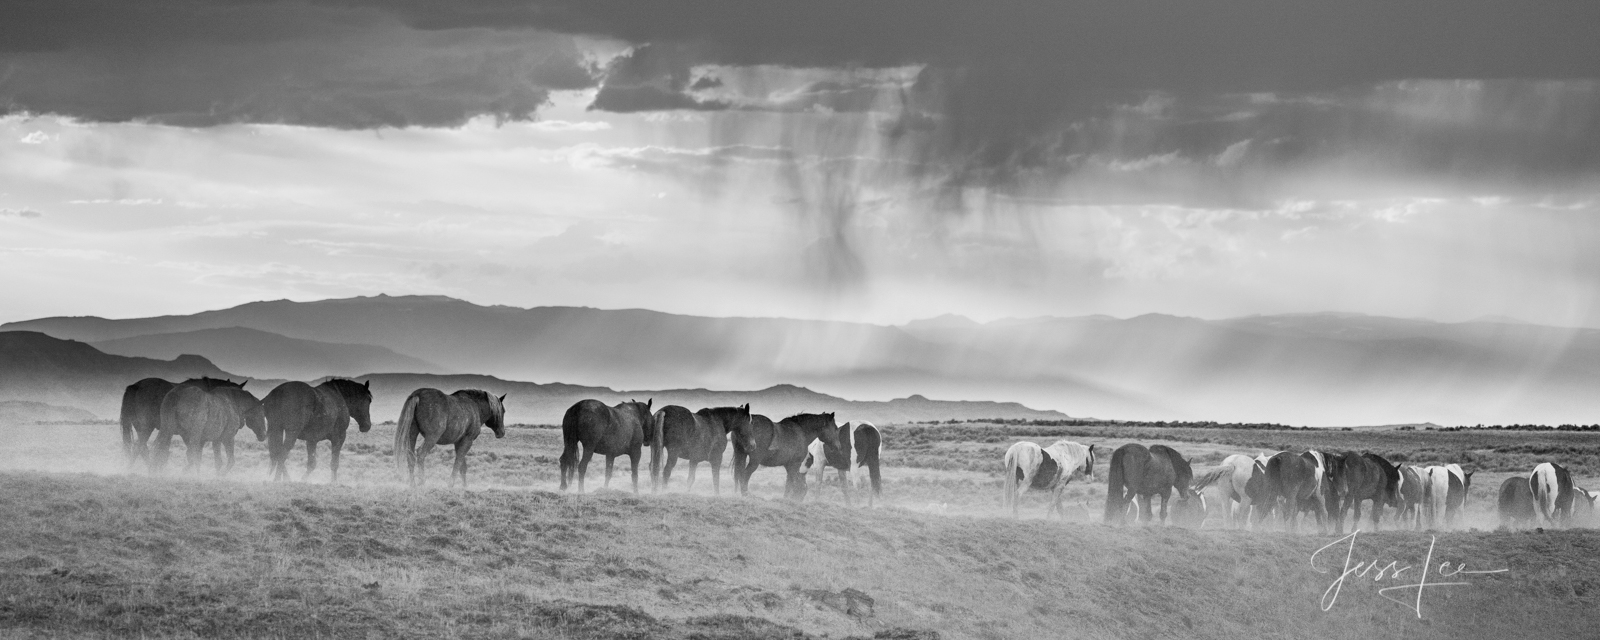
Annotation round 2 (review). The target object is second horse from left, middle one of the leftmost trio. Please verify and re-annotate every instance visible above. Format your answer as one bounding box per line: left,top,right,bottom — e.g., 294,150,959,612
149,384,267,475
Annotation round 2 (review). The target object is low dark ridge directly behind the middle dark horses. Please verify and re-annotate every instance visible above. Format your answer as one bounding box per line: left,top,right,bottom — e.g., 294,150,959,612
340,374,1067,424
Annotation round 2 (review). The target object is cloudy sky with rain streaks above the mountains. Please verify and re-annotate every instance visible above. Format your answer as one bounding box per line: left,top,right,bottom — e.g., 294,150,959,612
0,0,1600,326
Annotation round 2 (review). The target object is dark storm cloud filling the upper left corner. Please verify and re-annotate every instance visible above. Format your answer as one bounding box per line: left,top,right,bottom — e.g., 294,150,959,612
0,0,595,128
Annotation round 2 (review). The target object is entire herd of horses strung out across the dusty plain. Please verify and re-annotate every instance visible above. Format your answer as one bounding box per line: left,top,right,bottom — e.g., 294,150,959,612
122,378,1600,534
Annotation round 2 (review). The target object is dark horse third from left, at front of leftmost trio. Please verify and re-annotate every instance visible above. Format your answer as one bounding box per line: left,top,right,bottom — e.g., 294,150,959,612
261,378,373,482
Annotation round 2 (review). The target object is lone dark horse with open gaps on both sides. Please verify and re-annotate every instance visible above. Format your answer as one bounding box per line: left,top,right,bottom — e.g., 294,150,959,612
395,387,506,488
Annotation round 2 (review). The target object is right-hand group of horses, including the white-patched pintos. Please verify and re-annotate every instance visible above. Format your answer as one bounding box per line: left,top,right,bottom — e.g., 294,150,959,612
1002,440,1600,534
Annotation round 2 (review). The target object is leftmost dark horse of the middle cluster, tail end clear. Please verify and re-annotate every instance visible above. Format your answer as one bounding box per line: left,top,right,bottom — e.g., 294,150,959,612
560,400,654,493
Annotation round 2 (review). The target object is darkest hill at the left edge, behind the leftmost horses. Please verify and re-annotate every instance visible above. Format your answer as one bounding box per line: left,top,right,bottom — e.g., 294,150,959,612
0,331,236,419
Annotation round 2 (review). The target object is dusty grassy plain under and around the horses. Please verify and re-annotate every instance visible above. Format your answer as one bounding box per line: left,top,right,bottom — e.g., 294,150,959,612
0,424,1600,638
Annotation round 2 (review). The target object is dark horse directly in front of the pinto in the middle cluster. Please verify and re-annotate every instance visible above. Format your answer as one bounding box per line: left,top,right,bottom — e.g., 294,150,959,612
733,413,840,501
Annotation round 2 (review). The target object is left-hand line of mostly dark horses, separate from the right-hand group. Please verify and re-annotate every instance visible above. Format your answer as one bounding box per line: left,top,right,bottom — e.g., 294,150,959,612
120,378,882,504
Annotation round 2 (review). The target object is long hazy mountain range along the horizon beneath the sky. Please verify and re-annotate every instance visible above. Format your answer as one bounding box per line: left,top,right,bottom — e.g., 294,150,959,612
9,296,1600,424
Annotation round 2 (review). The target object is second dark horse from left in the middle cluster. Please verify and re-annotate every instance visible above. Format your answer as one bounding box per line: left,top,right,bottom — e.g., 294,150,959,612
646,405,750,496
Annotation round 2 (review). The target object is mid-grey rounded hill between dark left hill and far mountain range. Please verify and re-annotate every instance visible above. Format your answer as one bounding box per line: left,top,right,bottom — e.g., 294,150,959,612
91,326,451,379
